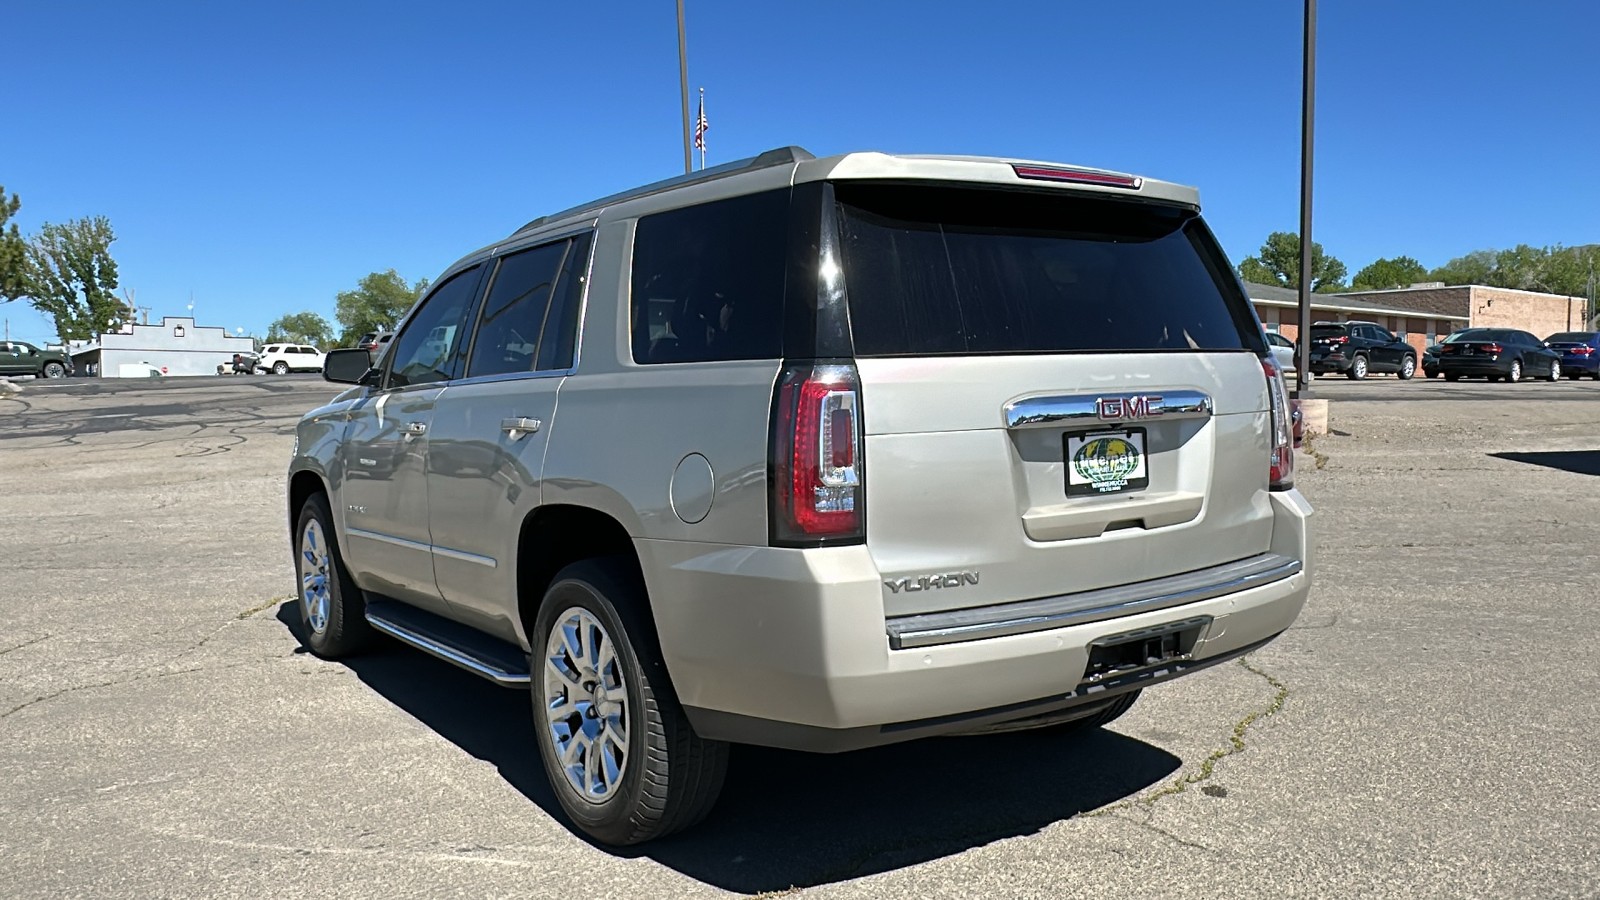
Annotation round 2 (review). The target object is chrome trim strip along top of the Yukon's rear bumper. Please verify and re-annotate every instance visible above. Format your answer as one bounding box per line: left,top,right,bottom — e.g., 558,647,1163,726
886,552,1304,650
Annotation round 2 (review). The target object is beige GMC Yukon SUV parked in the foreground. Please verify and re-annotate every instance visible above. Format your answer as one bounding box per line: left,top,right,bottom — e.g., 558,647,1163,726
288,149,1310,844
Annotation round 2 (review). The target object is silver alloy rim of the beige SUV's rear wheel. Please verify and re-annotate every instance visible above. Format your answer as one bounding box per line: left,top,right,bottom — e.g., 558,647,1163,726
544,607,629,804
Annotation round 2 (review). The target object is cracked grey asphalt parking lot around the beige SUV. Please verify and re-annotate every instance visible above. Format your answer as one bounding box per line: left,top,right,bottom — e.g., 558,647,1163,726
0,376,1600,900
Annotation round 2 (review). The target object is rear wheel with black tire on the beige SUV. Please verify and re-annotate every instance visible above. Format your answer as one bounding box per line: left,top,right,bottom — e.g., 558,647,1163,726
530,559,728,846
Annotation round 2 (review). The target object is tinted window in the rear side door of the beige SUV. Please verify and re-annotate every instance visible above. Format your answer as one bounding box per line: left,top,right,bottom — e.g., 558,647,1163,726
467,240,568,376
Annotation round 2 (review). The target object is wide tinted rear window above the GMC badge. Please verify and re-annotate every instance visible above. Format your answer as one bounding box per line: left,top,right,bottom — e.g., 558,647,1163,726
835,183,1259,357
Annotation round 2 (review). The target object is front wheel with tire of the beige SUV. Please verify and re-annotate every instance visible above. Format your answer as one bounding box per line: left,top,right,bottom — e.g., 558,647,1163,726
293,493,376,660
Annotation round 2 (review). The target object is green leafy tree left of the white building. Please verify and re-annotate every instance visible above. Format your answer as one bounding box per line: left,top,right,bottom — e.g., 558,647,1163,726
22,216,125,341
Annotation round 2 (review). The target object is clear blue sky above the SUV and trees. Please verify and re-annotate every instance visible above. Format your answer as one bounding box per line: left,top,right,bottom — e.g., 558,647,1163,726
0,0,1600,341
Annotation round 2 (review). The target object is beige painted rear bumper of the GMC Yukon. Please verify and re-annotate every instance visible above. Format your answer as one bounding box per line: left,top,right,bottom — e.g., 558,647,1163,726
637,492,1312,751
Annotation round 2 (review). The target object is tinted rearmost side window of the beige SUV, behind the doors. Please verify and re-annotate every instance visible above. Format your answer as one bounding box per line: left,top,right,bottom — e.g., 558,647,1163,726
632,191,789,364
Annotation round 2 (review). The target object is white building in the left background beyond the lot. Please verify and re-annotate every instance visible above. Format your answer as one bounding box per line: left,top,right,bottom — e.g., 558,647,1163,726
72,315,254,378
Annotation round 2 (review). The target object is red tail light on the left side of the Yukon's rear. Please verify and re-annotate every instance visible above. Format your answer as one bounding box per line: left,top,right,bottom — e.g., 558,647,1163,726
768,364,866,546
